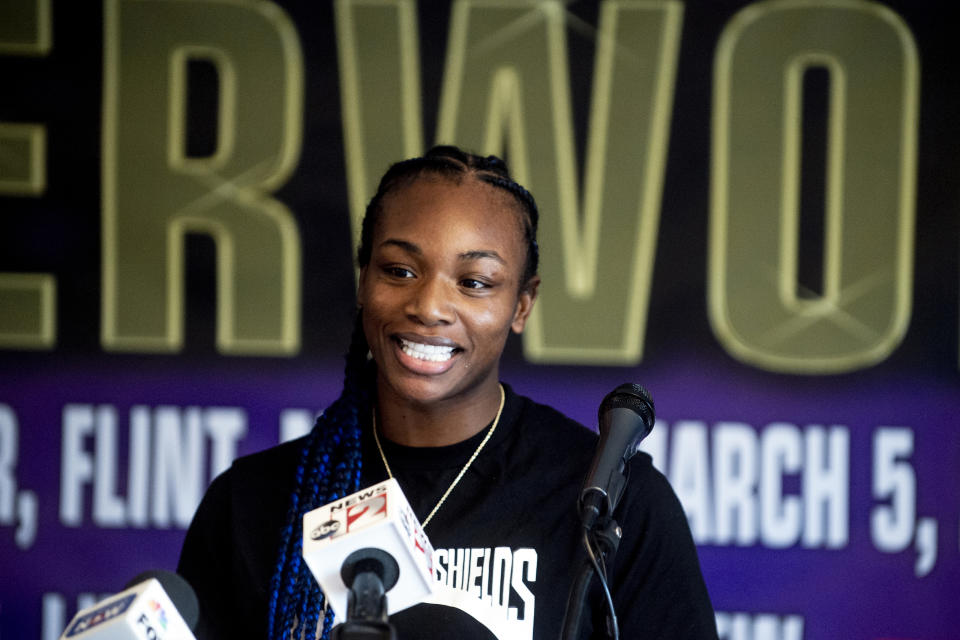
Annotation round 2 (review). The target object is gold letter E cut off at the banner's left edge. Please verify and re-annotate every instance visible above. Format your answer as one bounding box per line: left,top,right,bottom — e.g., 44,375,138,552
0,0,57,349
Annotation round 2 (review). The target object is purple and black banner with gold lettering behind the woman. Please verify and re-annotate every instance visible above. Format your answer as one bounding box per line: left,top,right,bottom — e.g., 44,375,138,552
0,0,960,640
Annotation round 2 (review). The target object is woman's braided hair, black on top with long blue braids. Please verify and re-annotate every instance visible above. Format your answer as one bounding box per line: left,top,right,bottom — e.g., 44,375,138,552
268,146,539,640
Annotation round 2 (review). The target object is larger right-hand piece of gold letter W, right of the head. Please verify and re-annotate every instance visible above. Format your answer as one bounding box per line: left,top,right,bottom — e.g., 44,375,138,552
437,0,683,365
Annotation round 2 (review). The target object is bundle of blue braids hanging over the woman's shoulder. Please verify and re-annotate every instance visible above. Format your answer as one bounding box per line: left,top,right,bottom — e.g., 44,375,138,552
268,316,370,640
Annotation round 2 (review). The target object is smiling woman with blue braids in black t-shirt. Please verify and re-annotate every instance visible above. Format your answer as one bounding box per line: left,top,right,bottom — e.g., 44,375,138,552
179,147,716,640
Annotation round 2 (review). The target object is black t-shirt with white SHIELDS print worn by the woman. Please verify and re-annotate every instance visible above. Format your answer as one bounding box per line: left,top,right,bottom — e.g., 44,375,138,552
179,385,716,640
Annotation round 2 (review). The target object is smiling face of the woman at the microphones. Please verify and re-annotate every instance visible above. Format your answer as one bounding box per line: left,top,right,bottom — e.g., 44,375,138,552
357,176,539,404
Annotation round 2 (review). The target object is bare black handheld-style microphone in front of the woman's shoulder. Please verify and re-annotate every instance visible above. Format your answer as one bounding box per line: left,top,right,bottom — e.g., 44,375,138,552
580,382,654,530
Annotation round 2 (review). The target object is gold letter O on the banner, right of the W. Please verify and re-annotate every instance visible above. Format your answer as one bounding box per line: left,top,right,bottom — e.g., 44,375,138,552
709,0,919,374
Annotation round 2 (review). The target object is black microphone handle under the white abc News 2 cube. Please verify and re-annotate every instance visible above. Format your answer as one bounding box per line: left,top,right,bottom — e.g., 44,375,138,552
331,547,400,640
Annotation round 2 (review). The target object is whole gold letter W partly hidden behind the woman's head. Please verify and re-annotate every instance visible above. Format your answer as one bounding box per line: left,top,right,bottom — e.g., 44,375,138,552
336,0,683,364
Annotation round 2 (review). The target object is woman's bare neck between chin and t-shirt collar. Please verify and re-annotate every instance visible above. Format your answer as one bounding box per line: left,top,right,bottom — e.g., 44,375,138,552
376,384,501,447
